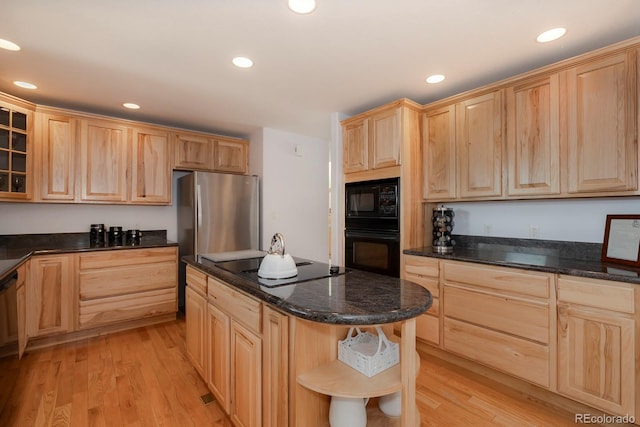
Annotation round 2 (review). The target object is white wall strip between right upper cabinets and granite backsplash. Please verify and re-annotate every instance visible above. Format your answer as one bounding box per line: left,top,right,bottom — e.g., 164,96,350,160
442,197,640,243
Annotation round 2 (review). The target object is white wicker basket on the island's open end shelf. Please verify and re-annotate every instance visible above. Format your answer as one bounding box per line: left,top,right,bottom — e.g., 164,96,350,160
338,326,400,378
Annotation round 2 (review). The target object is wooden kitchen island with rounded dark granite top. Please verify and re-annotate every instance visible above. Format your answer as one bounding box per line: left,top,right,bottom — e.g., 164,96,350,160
182,256,432,427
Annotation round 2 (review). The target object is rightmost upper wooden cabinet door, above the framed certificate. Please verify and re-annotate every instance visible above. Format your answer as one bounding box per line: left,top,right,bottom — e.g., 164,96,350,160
567,52,638,193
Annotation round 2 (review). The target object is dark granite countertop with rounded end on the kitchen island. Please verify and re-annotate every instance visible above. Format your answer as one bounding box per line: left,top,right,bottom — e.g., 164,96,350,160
182,256,432,325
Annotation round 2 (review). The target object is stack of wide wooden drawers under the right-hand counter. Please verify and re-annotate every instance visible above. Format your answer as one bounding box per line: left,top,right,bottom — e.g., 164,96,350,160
443,262,555,388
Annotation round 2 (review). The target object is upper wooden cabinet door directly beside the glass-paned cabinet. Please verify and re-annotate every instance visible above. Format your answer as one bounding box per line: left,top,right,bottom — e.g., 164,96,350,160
36,113,76,200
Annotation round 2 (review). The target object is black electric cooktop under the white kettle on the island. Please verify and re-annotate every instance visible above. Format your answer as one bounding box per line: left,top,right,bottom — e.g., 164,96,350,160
216,257,350,288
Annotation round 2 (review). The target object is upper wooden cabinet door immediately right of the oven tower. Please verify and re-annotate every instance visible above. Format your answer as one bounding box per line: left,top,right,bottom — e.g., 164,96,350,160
422,105,456,201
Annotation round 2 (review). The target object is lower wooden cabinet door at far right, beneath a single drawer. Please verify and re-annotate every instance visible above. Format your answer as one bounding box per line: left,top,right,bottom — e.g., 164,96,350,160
558,303,637,415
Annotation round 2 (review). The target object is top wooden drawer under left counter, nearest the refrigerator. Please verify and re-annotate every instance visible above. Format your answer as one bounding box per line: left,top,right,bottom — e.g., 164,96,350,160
79,247,178,270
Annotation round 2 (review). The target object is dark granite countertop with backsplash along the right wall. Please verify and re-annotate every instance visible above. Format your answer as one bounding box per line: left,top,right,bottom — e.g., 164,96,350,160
404,236,640,284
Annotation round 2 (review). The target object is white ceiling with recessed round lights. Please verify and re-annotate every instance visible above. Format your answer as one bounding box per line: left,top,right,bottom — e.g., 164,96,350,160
0,0,640,139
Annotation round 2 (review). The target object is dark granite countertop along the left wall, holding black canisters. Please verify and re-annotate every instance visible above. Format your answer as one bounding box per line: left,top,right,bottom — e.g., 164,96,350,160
0,230,178,280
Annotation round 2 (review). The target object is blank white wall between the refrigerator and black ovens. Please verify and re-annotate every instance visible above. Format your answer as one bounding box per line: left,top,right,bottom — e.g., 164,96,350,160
250,128,329,262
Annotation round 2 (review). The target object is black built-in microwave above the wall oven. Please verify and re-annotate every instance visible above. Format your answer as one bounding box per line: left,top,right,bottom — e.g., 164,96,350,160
345,178,400,230
